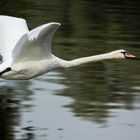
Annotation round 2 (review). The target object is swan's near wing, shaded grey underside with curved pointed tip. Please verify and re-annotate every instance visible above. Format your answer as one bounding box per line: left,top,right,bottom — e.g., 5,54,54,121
13,22,60,63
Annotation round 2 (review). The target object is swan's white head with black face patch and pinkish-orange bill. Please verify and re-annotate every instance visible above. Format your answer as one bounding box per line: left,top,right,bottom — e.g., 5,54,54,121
110,49,135,59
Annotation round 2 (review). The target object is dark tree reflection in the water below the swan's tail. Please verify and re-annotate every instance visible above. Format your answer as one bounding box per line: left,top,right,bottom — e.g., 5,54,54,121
0,81,32,140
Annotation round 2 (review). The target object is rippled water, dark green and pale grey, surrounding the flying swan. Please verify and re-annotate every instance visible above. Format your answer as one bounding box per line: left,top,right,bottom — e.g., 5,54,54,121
0,0,140,140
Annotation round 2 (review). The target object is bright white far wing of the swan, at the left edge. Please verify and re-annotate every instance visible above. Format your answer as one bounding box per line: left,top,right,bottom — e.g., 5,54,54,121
0,16,28,63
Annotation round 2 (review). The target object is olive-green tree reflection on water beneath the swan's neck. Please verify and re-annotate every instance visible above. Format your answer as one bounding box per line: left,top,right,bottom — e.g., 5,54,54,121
58,59,139,123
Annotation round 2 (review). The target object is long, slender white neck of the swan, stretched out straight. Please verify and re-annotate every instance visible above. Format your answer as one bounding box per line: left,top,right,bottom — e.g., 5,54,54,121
56,53,115,68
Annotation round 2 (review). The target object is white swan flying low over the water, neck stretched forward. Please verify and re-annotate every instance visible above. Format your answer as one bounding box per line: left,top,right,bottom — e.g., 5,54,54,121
0,16,135,80
